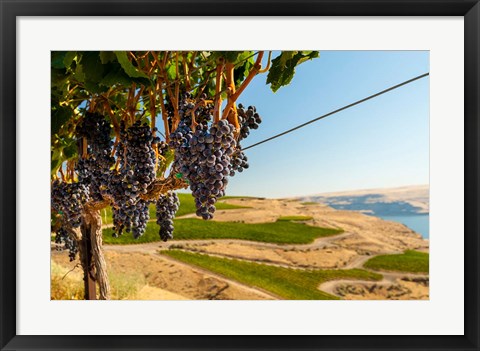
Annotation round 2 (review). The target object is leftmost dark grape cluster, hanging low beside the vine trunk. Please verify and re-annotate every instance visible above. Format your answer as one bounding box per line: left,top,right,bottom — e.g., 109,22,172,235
51,180,89,228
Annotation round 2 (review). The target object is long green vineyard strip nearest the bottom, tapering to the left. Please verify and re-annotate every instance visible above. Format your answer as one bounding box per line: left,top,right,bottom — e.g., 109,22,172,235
160,250,382,300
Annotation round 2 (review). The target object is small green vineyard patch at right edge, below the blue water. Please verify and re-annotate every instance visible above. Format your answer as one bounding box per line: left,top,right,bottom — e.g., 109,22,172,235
363,250,429,273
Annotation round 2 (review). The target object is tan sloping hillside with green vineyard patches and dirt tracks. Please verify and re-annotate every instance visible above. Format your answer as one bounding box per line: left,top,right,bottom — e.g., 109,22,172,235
51,194,428,300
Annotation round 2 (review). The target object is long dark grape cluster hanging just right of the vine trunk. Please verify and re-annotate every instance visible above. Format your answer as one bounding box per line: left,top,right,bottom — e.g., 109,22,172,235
109,122,158,239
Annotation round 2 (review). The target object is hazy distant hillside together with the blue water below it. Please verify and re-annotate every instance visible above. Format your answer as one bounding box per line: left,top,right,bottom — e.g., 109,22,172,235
298,185,429,216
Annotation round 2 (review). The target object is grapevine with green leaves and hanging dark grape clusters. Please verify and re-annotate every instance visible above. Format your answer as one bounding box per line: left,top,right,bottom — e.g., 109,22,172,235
51,51,318,302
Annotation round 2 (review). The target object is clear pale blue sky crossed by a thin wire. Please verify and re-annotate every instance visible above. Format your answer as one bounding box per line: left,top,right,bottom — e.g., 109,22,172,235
212,51,429,197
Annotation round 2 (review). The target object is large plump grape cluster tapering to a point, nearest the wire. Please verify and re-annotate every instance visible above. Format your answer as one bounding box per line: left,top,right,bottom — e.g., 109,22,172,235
170,120,236,219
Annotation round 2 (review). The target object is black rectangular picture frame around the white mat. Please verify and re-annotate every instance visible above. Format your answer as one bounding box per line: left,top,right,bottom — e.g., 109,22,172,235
0,0,480,350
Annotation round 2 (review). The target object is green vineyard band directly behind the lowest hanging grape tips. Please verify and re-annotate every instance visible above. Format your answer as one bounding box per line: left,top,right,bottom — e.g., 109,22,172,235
103,218,343,244
